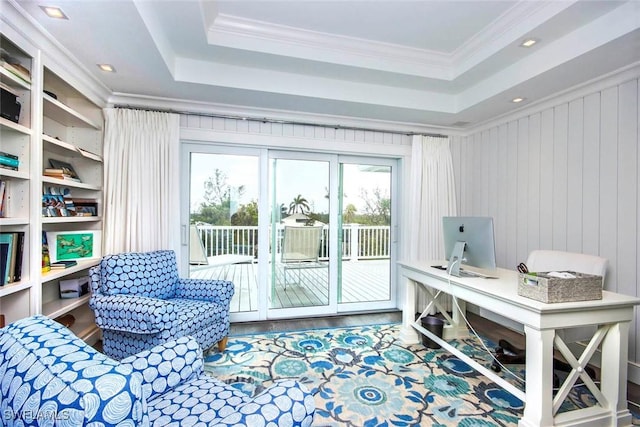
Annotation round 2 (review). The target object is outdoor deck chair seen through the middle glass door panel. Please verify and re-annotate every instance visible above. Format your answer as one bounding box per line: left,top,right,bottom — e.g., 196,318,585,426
280,226,328,289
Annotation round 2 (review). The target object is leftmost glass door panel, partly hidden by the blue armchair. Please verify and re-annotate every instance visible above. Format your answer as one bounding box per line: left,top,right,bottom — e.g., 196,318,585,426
189,152,259,313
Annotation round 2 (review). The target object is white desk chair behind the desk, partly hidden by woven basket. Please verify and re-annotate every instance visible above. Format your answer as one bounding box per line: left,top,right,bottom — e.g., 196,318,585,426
494,250,607,382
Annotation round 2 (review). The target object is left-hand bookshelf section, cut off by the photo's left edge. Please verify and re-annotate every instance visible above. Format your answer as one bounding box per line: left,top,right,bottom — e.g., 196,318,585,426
0,34,37,323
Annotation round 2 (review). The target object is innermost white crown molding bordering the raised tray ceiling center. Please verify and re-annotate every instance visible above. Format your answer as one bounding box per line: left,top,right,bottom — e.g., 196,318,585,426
206,0,576,81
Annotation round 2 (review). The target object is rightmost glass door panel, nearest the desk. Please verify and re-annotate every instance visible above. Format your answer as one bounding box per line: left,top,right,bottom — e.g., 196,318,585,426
338,163,392,304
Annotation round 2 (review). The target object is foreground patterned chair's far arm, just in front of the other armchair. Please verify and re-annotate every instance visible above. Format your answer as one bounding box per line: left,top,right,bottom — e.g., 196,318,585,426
120,336,204,401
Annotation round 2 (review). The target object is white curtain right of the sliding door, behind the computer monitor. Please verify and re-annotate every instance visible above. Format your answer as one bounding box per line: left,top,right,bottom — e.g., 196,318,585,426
409,135,457,308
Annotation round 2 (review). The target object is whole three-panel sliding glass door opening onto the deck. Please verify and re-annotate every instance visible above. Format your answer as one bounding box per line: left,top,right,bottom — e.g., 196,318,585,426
183,144,397,321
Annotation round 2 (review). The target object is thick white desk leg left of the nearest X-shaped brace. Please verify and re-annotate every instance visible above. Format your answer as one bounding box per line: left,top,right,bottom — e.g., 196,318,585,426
518,326,555,427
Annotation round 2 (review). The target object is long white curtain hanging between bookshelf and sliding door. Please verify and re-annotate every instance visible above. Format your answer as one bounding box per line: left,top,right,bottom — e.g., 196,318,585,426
103,108,180,254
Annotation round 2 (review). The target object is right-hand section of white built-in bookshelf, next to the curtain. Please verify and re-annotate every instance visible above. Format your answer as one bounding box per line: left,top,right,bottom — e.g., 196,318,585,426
41,66,103,342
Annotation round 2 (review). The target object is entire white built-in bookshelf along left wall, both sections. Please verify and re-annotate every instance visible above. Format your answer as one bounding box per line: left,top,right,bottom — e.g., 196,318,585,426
0,26,103,343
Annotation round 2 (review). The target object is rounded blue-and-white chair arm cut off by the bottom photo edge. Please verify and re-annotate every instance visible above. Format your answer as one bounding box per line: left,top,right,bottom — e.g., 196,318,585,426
215,379,316,427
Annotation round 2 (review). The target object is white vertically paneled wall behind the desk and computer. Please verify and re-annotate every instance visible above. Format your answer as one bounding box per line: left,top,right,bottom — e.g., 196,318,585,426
452,76,640,374
